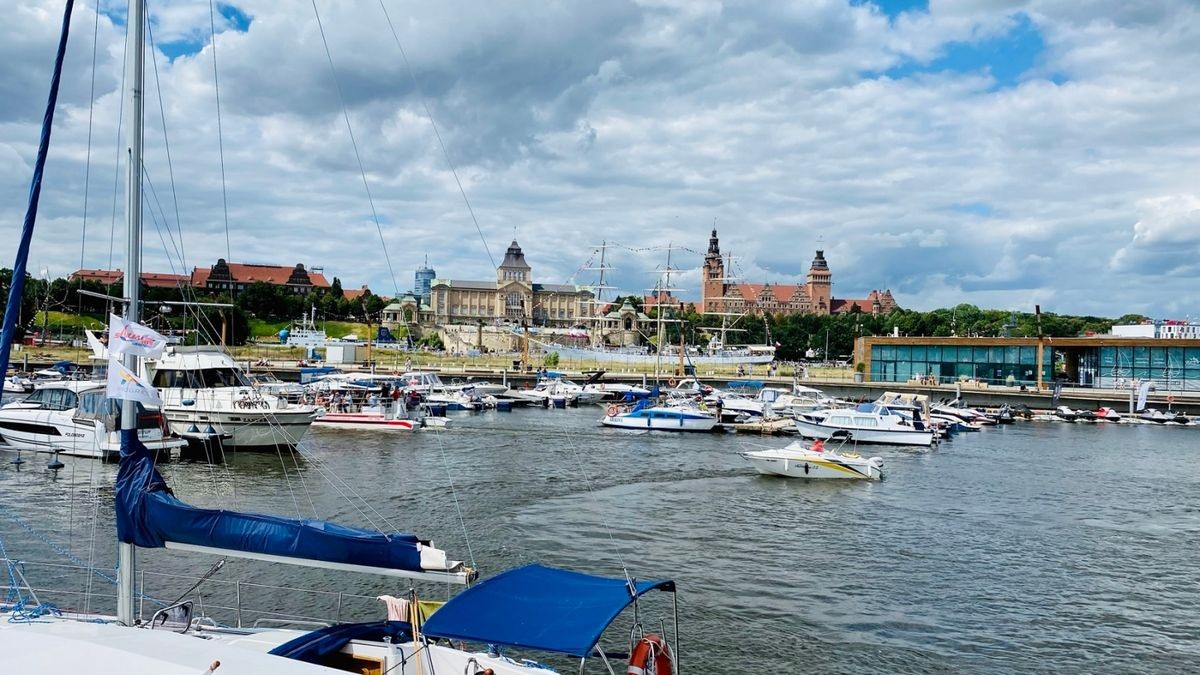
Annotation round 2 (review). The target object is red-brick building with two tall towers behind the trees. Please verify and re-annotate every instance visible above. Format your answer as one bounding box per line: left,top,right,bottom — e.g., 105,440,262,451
700,228,896,315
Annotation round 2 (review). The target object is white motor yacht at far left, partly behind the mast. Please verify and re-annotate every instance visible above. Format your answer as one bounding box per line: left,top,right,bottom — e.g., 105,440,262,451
0,381,187,460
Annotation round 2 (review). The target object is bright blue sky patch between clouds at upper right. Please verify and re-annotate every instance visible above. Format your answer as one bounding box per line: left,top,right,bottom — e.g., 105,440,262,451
883,13,1064,89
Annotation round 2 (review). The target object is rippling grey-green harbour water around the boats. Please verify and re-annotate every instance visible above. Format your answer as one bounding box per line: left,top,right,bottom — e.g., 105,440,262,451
0,408,1200,673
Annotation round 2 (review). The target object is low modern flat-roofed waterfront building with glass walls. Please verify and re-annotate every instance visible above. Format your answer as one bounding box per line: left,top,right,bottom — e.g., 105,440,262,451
854,335,1200,392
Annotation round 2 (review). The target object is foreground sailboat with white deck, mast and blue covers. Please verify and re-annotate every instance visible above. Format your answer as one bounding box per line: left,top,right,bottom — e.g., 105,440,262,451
0,0,678,675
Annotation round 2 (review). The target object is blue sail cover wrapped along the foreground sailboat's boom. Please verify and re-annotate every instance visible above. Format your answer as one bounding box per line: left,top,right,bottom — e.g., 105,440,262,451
116,430,422,572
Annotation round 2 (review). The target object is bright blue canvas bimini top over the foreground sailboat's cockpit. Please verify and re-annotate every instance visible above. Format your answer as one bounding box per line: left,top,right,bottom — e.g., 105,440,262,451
425,565,674,657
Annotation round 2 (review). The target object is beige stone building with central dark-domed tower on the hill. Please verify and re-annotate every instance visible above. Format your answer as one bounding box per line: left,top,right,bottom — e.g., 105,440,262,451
430,239,594,328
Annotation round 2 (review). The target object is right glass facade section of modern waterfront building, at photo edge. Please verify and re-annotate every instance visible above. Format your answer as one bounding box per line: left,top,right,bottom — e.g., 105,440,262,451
1096,347,1200,392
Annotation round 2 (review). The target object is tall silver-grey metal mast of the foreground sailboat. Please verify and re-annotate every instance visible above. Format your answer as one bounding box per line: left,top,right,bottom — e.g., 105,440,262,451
116,0,145,626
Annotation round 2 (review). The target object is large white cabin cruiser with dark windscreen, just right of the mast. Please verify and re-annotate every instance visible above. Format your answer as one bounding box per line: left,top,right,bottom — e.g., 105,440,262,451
146,346,317,450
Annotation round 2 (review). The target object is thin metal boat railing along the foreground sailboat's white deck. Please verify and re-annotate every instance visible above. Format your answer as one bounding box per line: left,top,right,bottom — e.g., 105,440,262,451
0,557,384,628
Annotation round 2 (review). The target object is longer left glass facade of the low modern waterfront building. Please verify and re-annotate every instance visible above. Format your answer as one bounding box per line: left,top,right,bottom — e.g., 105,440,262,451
871,345,1051,384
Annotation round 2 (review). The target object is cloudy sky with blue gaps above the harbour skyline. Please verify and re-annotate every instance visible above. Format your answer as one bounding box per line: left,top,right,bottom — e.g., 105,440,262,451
0,0,1200,318
